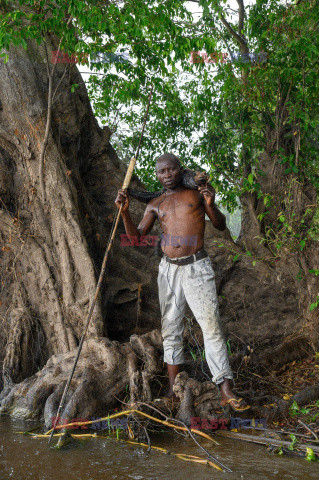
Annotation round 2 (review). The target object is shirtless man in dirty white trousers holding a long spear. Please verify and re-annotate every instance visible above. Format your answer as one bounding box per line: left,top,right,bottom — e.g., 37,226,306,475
115,153,249,411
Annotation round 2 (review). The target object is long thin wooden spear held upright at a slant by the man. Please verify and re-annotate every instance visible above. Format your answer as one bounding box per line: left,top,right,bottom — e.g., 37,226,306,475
49,85,153,444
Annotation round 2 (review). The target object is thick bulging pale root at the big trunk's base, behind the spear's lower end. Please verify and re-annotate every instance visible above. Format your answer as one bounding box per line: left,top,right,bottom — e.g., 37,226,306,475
0,330,162,427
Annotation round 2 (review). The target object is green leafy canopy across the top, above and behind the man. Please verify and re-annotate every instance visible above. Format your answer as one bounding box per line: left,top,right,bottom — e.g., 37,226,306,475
0,0,319,258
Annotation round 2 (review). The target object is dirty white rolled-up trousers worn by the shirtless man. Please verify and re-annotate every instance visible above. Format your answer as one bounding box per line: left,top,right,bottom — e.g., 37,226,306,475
157,256,233,384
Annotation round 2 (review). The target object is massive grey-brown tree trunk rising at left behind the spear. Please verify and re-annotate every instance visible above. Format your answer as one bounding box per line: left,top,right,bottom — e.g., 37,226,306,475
0,38,164,416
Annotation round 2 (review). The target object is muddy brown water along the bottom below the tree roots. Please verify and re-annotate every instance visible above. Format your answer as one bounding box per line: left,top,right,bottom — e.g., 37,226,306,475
0,416,319,480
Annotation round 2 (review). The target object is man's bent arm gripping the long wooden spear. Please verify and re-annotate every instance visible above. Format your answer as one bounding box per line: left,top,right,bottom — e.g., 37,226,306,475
115,190,156,240
